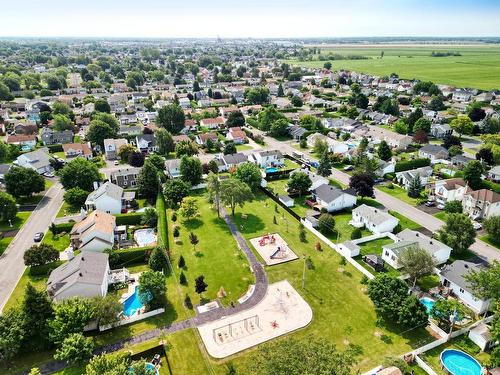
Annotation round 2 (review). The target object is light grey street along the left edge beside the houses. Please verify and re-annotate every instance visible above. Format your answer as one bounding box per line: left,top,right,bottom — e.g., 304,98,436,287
0,181,64,312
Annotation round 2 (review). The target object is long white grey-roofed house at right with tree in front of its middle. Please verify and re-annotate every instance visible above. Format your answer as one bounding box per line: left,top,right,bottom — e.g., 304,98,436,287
382,229,451,269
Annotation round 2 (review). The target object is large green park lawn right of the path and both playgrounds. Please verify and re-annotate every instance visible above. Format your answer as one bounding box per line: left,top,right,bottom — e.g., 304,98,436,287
221,194,431,373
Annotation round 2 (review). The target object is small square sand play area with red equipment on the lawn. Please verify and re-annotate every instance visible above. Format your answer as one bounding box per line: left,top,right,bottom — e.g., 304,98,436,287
250,233,299,266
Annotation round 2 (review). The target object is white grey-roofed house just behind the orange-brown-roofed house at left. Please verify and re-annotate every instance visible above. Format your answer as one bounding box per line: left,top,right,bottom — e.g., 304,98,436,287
85,181,135,214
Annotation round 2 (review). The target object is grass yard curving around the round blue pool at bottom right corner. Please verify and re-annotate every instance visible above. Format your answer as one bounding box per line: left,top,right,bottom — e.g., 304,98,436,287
420,336,490,375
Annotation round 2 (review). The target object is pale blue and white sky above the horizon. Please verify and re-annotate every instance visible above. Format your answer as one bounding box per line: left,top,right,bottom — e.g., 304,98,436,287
0,0,500,38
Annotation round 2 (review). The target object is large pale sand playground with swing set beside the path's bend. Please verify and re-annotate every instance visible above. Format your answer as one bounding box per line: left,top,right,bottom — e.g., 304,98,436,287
198,280,312,358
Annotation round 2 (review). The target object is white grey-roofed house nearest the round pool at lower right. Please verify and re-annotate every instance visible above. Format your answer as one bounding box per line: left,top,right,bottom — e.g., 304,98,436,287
439,260,491,314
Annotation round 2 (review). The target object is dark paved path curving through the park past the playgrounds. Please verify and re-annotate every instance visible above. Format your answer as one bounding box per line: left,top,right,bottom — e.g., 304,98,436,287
40,207,269,374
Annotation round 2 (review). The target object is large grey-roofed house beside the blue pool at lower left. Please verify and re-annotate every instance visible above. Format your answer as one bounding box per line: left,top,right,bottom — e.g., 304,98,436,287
47,251,110,302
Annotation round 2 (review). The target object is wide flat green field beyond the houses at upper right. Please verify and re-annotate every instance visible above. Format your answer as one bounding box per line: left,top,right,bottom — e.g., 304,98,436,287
284,45,500,90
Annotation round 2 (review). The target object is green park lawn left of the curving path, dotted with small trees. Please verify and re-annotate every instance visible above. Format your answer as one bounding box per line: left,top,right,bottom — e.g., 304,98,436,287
169,191,254,306
